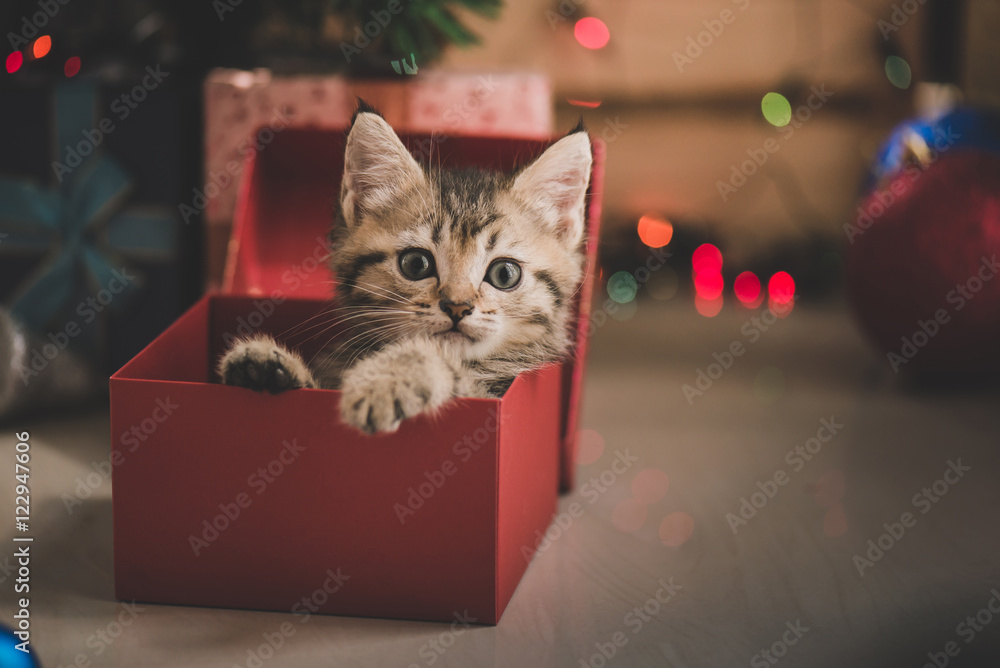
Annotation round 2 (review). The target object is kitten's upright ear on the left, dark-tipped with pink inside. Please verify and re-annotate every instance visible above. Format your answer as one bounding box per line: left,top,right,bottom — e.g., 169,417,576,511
340,109,427,227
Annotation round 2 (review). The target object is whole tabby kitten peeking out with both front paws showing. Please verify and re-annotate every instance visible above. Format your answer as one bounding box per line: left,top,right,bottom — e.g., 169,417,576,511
219,103,592,434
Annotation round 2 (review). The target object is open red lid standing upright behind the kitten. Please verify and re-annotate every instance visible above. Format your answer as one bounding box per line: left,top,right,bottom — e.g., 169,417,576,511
223,128,604,490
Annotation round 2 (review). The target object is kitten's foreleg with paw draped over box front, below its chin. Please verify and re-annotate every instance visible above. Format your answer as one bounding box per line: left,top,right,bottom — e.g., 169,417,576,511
340,338,482,434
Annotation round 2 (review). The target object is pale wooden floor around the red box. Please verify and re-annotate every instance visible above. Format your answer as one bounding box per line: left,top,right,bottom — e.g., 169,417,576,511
0,300,1000,668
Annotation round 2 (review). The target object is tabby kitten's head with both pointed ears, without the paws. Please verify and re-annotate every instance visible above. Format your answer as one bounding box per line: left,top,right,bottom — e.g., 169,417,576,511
333,113,591,366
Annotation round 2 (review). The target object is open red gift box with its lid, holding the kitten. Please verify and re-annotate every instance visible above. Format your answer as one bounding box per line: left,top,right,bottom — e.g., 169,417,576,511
111,129,603,624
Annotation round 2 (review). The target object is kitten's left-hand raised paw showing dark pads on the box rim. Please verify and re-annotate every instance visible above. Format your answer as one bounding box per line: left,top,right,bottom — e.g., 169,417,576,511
218,334,319,394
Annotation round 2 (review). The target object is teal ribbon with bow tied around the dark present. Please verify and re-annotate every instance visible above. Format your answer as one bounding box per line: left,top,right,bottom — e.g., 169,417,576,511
0,81,176,331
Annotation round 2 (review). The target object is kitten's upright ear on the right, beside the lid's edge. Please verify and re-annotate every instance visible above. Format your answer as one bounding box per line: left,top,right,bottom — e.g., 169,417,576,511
512,131,593,248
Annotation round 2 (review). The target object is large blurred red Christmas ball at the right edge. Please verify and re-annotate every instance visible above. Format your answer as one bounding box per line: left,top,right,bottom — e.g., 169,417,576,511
845,149,1000,374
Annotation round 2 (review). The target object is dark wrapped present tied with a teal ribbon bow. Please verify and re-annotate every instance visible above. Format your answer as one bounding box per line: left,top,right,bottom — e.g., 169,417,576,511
0,76,183,381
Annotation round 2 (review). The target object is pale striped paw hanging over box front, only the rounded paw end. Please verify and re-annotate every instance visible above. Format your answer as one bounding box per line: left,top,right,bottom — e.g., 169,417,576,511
340,354,454,434
